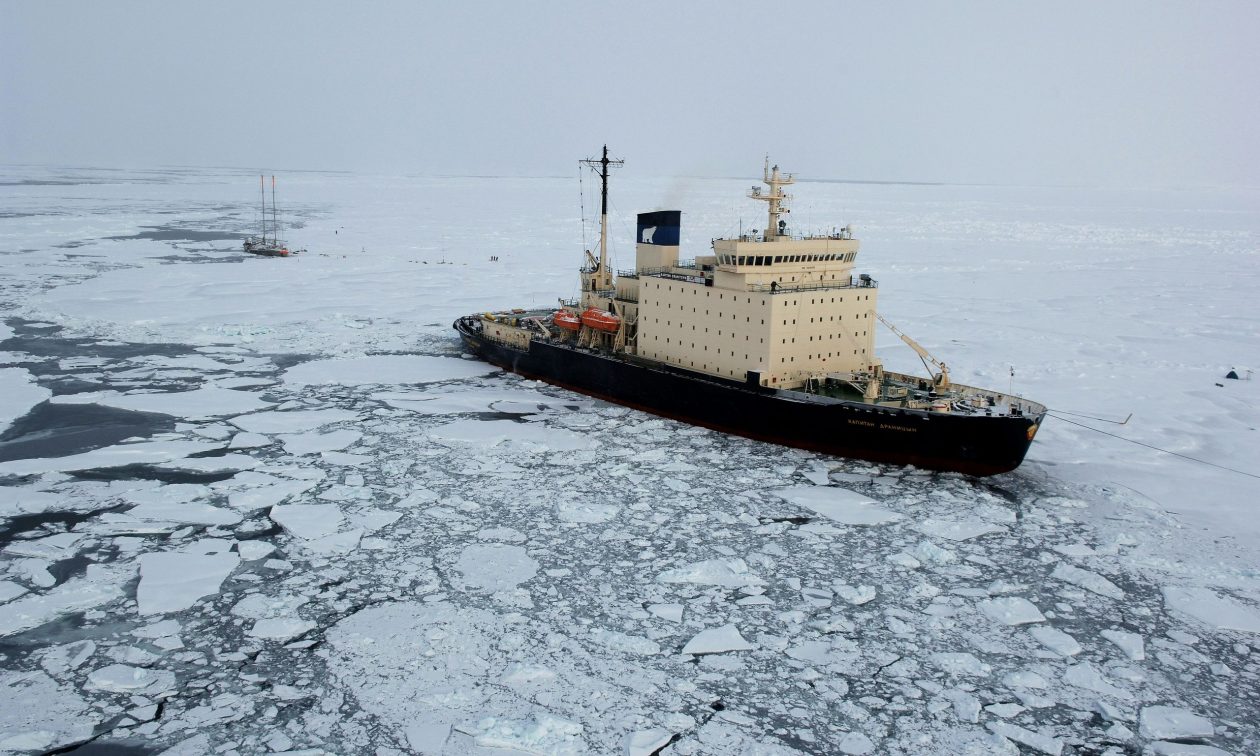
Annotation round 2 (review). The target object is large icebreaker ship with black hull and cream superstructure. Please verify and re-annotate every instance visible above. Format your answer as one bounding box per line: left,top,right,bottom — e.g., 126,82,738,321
454,146,1046,475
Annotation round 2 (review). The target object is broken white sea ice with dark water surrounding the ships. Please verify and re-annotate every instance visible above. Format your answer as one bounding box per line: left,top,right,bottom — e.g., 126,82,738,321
0,166,1260,756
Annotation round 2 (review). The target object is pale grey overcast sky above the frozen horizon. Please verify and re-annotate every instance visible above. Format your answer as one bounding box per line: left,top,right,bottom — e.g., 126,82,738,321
0,0,1260,186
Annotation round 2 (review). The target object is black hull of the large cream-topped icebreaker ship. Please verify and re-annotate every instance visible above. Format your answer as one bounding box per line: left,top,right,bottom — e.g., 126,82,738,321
455,319,1041,475
